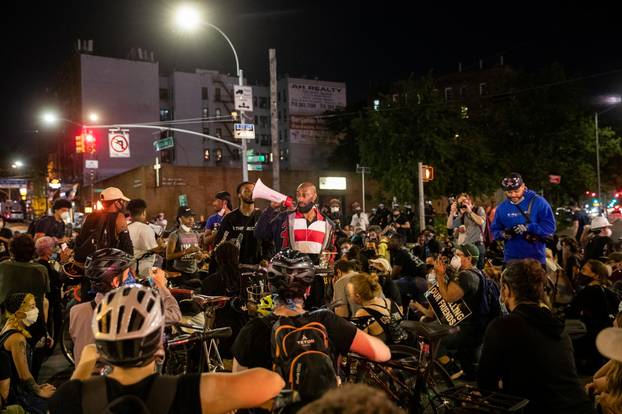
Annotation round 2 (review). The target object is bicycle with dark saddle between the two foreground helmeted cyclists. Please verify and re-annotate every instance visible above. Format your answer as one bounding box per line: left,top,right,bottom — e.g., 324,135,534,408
162,289,232,375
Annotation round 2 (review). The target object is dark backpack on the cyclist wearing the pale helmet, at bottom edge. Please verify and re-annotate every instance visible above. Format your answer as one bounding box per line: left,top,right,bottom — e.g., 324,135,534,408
82,375,179,414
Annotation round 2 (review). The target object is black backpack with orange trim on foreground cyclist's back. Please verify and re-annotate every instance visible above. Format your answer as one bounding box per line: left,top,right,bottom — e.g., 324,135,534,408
265,313,337,402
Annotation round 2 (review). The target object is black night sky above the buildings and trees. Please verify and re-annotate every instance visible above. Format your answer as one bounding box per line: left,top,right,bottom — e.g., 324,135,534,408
0,0,622,165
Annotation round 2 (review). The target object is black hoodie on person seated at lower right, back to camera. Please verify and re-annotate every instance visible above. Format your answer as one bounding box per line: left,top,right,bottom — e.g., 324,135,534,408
478,304,594,414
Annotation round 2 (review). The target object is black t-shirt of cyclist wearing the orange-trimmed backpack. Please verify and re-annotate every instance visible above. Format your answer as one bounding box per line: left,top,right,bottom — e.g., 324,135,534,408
233,309,356,370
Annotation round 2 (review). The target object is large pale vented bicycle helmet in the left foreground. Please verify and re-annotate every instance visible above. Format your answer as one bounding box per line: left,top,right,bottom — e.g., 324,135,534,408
91,285,164,367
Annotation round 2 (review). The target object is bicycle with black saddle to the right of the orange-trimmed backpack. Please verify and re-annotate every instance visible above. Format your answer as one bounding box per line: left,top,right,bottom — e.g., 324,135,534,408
343,321,458,413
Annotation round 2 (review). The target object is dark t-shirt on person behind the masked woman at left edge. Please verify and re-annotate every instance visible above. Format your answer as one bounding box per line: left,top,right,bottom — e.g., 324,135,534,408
0,260,50,341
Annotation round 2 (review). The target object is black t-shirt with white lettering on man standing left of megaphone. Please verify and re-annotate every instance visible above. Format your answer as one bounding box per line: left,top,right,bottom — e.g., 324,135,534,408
214,208,261,264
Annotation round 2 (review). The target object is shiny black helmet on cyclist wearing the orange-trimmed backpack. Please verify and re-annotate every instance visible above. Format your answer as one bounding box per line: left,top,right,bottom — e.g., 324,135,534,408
268,249,315,299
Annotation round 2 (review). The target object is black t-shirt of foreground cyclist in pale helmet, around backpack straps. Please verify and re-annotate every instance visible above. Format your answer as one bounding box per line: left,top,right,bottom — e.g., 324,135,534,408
48,374,201,414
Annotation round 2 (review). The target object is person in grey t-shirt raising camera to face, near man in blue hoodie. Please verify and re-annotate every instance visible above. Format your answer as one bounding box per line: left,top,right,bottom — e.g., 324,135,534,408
447,193,486,269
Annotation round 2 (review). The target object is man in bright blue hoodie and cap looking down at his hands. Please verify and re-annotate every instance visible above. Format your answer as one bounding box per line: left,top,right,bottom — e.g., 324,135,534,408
490,173,556,264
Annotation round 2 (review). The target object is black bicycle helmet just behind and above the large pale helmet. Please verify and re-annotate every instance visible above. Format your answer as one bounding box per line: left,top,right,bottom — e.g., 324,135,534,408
84,248,134,291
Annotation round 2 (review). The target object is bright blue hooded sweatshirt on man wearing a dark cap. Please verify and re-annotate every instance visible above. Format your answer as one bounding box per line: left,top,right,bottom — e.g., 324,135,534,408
490,190,556,263
